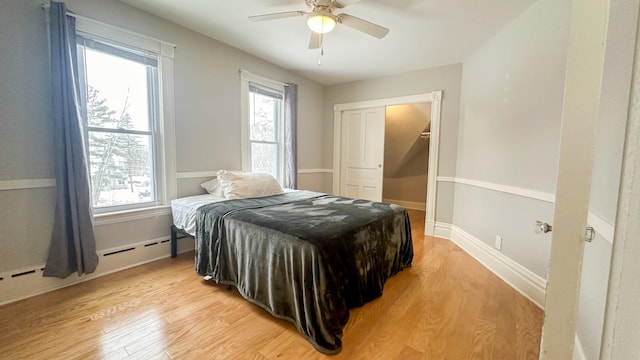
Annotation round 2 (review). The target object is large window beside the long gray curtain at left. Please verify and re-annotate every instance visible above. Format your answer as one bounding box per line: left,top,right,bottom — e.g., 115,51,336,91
77,19,173,213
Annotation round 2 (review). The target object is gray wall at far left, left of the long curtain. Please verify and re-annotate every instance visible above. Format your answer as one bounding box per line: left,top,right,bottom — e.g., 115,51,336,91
0,0,55,271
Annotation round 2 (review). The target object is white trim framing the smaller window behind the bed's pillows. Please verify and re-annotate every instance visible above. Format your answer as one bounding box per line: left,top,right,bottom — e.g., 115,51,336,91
240,69,286,180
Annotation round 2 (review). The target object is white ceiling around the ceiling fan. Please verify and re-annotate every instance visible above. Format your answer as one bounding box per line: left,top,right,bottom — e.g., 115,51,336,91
121,0,535,85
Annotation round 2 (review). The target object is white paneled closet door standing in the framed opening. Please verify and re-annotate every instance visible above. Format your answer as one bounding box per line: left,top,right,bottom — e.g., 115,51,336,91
339,107,385,201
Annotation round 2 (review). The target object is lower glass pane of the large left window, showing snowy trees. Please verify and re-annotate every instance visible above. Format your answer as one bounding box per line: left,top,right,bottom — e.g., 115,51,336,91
89,131,155,207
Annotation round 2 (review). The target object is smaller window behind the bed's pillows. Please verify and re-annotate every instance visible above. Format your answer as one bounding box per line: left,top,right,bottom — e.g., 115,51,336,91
242,72,284,183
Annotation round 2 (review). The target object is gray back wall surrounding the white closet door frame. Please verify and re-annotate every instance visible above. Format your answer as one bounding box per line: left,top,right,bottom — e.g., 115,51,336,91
324,64,462,223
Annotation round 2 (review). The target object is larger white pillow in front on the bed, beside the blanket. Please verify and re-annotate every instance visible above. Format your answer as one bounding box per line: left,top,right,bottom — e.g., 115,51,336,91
218,170,283,199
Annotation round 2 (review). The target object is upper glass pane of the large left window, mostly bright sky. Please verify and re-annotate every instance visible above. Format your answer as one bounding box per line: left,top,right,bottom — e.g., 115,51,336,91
85,48,156,131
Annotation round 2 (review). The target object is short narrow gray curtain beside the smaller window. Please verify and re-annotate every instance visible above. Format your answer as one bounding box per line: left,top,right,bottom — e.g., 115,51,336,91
283,83,298,189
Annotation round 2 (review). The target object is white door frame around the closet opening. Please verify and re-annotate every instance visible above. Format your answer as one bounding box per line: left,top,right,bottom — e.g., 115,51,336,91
332,90,442,235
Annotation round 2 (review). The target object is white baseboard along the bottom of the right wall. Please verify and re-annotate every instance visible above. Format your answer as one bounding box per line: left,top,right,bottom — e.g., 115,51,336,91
425,222,547,309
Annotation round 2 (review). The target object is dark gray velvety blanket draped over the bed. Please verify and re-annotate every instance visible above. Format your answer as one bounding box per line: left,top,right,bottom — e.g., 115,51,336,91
196,191,413,354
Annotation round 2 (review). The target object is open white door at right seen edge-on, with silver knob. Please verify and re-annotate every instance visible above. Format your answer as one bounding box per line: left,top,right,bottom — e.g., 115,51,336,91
540,0,610,359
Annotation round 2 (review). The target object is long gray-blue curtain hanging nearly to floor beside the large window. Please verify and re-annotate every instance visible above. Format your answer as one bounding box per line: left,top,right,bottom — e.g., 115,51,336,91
43,2,98,278
